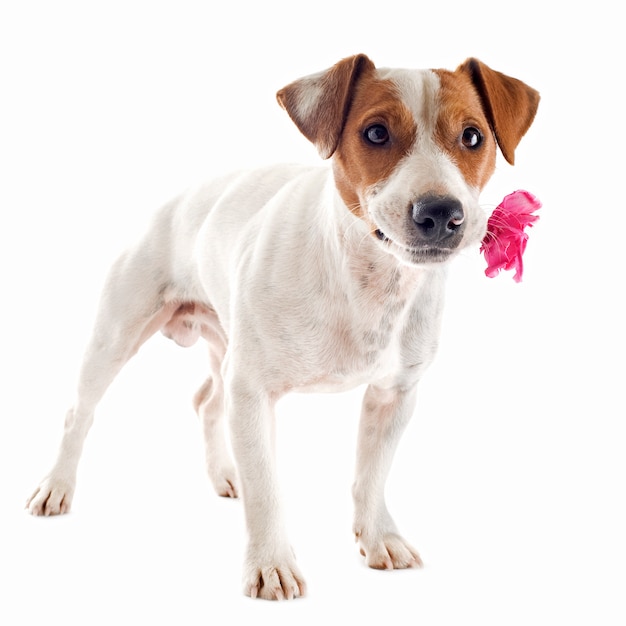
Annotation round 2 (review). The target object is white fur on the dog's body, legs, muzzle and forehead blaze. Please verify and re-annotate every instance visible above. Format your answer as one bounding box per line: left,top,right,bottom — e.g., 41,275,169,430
27,57,532,598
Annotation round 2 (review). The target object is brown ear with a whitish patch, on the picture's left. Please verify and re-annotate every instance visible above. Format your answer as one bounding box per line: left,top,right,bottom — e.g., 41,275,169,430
276,54,374,159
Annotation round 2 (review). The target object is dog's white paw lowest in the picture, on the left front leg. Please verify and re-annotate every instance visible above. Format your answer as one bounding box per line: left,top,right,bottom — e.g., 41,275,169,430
244,559,306,600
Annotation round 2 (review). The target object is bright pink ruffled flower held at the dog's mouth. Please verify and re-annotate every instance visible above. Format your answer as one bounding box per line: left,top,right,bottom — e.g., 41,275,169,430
480,190,541,283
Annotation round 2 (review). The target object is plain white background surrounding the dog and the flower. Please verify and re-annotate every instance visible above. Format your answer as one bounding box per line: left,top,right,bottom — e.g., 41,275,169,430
0,0,626,626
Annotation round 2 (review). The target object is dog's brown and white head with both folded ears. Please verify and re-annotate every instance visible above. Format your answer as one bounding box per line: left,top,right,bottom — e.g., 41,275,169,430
277,55,539,264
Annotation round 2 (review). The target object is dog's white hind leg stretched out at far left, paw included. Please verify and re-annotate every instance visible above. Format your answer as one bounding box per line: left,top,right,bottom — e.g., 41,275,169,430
26,250,177,515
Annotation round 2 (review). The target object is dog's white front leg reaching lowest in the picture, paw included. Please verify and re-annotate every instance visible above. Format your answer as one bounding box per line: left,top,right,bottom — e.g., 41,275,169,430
226,368,305,600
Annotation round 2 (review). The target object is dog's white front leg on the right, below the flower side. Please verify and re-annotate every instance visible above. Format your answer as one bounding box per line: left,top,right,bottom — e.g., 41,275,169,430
353,385,422,569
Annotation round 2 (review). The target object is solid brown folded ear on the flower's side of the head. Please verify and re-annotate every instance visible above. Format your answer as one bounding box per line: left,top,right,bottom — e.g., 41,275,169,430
457,59,539,165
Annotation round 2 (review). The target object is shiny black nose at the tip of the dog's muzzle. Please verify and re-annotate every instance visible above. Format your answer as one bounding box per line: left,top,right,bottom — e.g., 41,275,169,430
411,196,465,243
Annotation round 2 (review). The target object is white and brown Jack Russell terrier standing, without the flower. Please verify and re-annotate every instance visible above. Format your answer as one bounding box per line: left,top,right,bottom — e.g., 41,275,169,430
26,54,539,599
